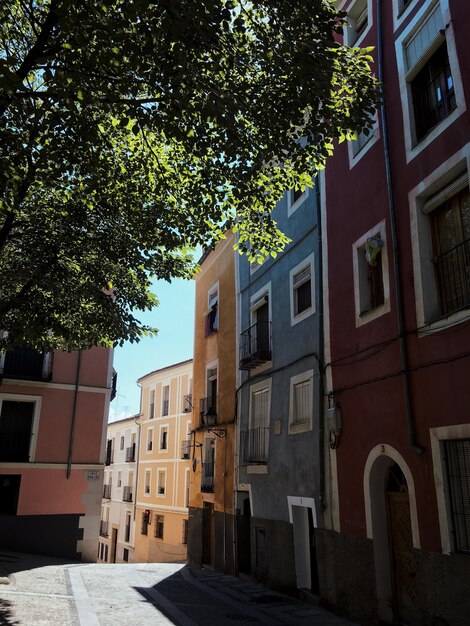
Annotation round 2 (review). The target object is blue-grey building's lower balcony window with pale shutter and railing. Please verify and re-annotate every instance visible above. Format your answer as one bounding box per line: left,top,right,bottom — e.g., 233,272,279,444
240,379,271,465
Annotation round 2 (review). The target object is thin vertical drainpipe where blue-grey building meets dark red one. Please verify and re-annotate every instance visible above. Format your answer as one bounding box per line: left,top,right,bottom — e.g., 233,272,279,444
315,175,326,511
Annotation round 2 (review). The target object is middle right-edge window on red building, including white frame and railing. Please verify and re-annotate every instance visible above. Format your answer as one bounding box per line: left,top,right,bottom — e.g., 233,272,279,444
410,156,470,328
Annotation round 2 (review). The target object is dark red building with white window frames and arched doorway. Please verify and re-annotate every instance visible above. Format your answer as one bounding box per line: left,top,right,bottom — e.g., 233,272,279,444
317,0,470,626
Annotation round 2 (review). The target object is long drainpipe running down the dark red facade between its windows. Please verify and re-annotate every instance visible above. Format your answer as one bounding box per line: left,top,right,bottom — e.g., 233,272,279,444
376,0,425,454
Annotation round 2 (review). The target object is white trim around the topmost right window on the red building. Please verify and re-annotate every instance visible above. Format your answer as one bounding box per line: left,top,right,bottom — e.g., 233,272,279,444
395,0,466,163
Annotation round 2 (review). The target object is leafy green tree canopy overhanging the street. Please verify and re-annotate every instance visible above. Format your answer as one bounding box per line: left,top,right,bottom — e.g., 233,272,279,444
0,0,377,350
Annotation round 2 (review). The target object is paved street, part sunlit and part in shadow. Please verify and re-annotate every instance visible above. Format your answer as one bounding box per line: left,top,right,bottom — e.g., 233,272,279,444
0,552,351,626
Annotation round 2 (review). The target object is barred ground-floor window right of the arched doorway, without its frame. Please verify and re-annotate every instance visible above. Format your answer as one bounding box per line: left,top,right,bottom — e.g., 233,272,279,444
444,439,470,554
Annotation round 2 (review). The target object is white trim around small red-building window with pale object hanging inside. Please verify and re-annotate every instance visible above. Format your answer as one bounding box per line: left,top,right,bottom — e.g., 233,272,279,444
352,220,390,328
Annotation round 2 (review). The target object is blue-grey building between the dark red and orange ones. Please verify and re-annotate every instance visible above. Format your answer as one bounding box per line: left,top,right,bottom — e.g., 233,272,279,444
235,182,324,592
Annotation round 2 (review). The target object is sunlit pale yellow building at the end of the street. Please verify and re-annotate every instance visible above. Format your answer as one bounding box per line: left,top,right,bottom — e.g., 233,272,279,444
135,360,193,563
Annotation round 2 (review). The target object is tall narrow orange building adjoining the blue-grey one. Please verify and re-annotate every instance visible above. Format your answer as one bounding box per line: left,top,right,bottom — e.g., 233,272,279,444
188,232,237,572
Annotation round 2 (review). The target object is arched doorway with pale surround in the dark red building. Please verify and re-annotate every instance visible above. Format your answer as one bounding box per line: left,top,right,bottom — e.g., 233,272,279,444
364,444,419,625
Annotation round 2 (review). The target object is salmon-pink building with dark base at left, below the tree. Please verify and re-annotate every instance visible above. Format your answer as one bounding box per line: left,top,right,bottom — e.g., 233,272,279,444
0,348,115,561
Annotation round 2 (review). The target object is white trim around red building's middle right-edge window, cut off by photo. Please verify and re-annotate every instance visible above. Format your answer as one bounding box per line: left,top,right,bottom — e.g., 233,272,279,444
408,142,470,336
